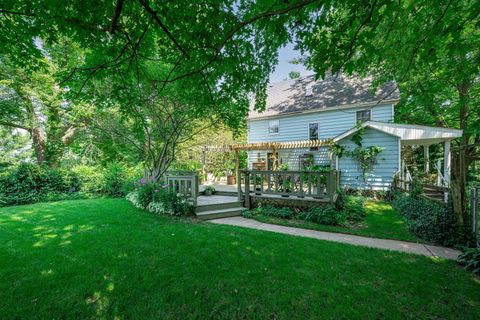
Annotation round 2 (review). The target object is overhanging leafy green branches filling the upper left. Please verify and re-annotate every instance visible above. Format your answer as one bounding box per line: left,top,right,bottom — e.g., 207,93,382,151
0,0,319,127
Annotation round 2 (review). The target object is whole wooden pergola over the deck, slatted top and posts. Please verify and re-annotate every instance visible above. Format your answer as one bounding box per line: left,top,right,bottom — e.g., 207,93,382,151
202,139,333,179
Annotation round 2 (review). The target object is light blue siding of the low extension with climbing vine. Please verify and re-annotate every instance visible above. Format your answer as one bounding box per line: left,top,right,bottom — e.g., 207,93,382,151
338,128,400,190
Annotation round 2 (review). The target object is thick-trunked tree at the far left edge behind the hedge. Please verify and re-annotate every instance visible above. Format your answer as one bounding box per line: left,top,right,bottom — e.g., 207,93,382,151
0,52,91,166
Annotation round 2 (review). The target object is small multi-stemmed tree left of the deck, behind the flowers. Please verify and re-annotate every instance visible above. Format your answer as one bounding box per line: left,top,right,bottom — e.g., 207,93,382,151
91,78,215,179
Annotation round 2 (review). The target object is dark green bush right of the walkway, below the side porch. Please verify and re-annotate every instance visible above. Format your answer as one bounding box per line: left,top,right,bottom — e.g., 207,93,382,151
392,194,460,246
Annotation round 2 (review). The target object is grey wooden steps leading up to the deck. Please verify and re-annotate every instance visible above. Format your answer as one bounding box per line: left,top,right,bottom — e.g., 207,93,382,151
195,195,246,220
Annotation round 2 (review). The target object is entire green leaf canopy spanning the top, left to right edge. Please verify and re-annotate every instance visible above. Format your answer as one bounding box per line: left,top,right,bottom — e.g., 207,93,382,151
0,0,480,221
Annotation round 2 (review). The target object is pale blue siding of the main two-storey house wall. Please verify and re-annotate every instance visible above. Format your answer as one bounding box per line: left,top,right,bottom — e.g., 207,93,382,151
247,104,393,170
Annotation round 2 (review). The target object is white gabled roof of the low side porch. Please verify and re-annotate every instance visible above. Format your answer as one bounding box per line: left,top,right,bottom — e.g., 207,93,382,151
333,121,463,145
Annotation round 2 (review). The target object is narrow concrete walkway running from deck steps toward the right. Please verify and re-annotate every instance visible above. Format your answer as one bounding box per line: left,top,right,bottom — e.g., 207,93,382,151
210,217,460,260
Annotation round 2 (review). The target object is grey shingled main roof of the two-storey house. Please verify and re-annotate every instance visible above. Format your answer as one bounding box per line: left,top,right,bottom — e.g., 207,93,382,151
249,72,400,119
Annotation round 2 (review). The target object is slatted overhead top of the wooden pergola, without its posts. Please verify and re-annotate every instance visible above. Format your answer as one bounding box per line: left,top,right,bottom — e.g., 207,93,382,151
202,139,332,152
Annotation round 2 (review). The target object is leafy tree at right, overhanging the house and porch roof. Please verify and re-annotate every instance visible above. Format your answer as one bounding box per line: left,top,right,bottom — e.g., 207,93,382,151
296,0,480,225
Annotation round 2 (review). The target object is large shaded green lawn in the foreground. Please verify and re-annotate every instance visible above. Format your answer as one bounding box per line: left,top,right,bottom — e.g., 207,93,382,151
0,199,480,319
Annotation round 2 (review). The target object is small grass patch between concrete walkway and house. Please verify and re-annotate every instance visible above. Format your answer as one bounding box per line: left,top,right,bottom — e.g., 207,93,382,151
254,201,424,242
